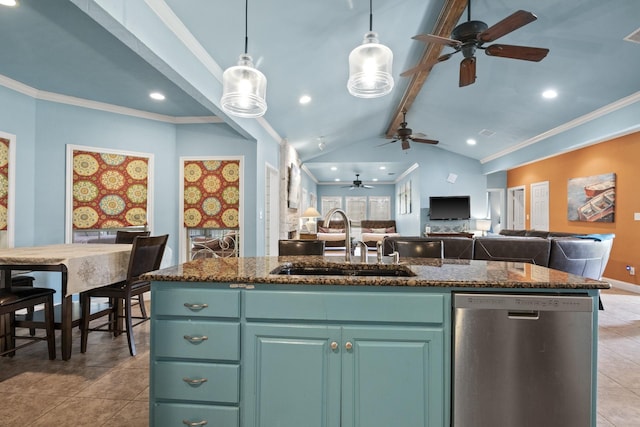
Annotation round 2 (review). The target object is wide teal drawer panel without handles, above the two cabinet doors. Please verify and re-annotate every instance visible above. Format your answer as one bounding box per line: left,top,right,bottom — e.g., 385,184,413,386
244,291,445,323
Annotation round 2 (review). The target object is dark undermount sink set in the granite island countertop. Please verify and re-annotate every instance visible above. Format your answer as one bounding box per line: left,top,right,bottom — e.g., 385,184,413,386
271,263,416,277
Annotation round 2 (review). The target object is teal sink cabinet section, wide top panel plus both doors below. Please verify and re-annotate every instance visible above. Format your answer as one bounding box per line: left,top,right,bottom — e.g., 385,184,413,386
242,291,448,427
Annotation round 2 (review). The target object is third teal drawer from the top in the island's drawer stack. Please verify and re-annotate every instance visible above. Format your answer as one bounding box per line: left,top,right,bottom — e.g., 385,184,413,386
151,362,240,403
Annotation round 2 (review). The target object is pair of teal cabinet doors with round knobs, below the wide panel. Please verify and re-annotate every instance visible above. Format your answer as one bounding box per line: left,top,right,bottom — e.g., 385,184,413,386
243,324,444,427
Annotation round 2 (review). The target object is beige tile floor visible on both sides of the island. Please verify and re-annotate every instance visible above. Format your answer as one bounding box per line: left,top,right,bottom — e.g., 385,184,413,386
0,289,640,427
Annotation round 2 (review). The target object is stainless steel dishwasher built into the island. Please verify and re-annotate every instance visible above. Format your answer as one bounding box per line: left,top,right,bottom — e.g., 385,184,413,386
452,293,595,427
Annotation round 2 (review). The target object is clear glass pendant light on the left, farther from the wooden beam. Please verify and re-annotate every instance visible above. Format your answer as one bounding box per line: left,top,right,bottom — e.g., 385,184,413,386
220,0,267,118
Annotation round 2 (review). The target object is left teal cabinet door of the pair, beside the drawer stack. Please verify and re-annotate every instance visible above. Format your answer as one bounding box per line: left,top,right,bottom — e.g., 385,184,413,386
242,323,340,427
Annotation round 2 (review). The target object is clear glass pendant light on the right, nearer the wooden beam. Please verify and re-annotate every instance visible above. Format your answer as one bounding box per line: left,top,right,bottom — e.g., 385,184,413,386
347,0,393,98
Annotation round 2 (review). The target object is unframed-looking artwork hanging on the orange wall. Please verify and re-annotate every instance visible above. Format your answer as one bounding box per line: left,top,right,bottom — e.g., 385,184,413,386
567,173,616,222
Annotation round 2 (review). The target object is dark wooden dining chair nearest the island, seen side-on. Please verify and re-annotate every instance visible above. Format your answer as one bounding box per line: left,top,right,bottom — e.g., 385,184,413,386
80,234,169,356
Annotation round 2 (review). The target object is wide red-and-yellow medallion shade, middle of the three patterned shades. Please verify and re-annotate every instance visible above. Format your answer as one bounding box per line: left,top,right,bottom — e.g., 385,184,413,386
73,150,149,230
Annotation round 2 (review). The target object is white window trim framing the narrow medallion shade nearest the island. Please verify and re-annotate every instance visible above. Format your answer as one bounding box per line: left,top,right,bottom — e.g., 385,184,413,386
178,156,246,262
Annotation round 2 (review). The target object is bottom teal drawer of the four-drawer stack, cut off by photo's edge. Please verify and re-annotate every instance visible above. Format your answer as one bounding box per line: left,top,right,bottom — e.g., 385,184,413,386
152,403,240,427
